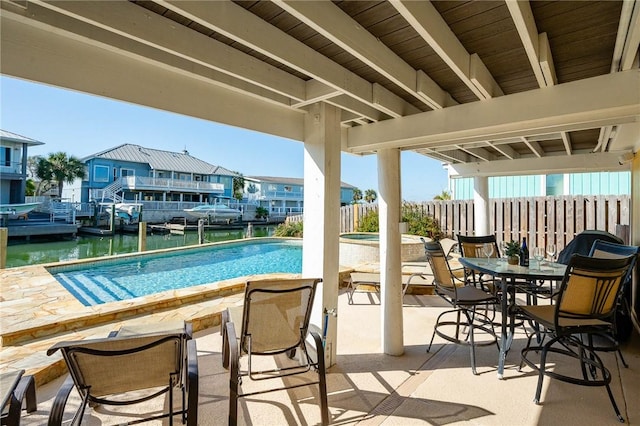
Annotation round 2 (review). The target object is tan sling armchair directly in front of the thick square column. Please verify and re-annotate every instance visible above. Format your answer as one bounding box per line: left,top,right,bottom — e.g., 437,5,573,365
221,278,329,425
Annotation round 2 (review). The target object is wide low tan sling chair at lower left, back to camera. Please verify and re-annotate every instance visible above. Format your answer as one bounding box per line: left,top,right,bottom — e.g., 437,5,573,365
47,322,198,426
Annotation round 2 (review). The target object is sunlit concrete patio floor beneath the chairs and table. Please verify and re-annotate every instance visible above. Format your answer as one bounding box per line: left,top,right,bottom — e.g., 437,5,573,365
16,292,640,426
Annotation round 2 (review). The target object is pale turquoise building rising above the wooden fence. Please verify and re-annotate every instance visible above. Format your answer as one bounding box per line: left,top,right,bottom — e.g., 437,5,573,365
449,171,631,200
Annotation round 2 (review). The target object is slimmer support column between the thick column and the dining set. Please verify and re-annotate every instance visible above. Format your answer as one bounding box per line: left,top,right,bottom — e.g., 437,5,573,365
378,148,404,356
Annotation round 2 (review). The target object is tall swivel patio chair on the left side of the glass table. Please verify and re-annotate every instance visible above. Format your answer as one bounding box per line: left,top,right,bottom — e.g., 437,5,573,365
425,241,497,374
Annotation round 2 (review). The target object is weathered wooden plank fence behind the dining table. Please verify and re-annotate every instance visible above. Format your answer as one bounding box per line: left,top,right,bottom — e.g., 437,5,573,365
289,195,631,252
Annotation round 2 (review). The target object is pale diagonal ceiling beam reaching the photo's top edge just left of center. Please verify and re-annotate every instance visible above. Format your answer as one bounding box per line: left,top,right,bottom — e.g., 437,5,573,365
272,0,446,108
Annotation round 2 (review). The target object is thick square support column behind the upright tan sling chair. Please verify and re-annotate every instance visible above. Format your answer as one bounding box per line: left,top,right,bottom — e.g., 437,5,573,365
302,103,340,366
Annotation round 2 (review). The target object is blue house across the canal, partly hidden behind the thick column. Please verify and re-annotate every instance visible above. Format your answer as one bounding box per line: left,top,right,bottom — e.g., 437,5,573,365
244,176,355,216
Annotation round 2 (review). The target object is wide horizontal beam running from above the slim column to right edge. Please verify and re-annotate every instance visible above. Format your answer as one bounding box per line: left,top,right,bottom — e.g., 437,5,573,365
347,70,640,152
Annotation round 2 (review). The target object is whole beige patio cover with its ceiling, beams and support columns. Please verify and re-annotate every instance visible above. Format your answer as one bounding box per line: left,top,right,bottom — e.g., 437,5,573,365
0,0,640,423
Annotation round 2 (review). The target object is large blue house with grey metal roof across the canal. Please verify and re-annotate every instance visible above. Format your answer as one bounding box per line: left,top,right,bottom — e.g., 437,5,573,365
63,144,236,206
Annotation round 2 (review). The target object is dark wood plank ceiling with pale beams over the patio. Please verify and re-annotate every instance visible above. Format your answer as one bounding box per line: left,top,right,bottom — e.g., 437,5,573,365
2,0,640,176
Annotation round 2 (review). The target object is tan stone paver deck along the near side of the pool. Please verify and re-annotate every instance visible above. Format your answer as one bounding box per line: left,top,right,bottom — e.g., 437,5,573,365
0,255,351,385
